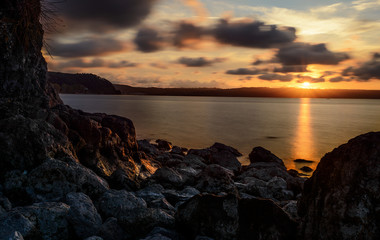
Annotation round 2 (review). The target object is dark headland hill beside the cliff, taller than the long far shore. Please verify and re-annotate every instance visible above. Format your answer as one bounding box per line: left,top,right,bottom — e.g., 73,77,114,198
48,72,120,94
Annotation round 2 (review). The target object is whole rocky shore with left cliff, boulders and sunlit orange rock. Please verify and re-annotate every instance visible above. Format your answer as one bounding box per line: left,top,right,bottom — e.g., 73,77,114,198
0,0,380,240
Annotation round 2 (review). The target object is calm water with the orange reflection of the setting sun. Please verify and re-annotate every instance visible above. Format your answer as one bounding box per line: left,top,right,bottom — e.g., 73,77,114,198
61,94,380,168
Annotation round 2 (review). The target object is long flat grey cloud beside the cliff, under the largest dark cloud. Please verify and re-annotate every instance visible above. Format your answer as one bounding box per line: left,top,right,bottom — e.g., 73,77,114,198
50,38,125,58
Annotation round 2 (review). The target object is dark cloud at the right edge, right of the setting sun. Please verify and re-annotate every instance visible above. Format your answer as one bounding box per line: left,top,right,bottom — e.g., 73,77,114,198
342,53,380,81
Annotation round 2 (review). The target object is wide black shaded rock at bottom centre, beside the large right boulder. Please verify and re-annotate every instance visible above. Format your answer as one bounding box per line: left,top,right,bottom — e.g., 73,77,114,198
176,194,297,239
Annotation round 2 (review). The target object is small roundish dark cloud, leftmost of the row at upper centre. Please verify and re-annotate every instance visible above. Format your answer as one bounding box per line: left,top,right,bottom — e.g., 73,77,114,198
134,28,167,53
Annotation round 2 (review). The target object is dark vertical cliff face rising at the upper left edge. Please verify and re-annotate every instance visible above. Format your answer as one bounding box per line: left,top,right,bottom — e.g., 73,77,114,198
0,0,61,107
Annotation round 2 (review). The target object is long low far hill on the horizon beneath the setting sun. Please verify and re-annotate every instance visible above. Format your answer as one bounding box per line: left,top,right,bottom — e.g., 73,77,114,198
114,84,380,99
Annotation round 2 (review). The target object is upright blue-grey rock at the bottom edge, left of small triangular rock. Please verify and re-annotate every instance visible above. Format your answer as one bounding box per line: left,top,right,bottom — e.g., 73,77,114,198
66,192,102,239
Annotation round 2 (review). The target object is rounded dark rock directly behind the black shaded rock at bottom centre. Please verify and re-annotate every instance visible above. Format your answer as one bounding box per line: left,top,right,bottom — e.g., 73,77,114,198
196,164,237,194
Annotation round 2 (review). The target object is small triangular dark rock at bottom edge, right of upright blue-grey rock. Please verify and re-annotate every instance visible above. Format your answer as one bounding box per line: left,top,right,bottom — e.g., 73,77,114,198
96,217,130,240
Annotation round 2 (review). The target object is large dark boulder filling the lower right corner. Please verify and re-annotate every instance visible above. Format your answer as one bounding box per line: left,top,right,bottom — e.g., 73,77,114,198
299,132,380,239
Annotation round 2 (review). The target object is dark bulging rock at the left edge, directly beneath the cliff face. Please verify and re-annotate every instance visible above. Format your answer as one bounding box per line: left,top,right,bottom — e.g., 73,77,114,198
0,115,73,175
